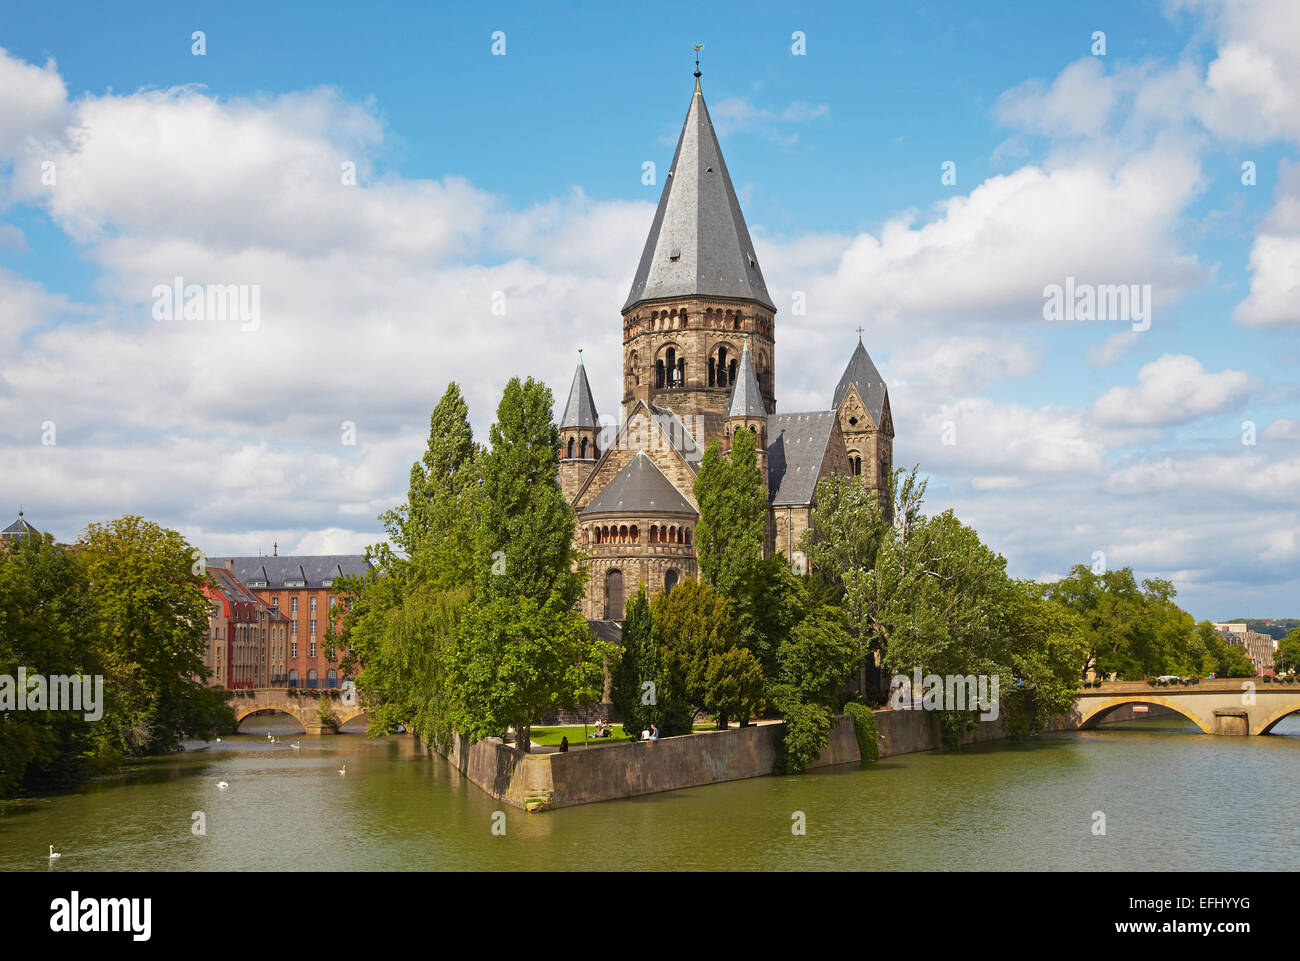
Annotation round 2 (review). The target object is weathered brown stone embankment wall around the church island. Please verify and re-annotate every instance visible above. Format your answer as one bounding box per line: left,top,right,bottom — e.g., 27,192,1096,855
426,706,1170,810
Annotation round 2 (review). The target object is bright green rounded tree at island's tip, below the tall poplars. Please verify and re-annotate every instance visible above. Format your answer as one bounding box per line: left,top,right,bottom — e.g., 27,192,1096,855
445,592,616,753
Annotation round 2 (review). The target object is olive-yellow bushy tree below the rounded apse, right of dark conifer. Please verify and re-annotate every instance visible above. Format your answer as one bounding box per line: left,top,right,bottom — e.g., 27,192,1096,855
650,577,763,728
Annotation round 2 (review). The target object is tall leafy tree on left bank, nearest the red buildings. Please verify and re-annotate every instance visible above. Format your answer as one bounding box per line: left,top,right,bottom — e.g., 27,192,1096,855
81,515,209,756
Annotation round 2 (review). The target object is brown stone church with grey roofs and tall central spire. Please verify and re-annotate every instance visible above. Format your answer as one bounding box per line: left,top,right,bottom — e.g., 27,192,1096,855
548,70,893,620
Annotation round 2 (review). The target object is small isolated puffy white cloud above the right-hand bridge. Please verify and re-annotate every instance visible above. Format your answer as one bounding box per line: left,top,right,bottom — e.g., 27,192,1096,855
1092,354,1255,427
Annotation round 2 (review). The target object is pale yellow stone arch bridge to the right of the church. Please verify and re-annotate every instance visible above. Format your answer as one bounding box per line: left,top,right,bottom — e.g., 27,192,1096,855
1074,678,1300,735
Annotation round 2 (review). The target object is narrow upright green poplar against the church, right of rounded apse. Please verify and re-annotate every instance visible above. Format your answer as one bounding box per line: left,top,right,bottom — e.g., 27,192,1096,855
696,430,767,598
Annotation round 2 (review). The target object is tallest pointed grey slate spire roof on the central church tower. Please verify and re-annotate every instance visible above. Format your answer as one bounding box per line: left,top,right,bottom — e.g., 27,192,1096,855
623,83,776,311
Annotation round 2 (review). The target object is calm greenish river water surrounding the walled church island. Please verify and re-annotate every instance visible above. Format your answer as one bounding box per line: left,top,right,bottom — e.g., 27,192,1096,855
0,717,1300,871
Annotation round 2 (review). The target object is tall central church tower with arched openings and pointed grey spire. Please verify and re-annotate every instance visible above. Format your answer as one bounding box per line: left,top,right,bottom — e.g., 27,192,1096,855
623,69,776,446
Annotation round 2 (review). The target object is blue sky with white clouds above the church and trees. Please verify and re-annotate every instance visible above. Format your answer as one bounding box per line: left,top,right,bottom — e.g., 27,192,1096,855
0,0,1300,618
